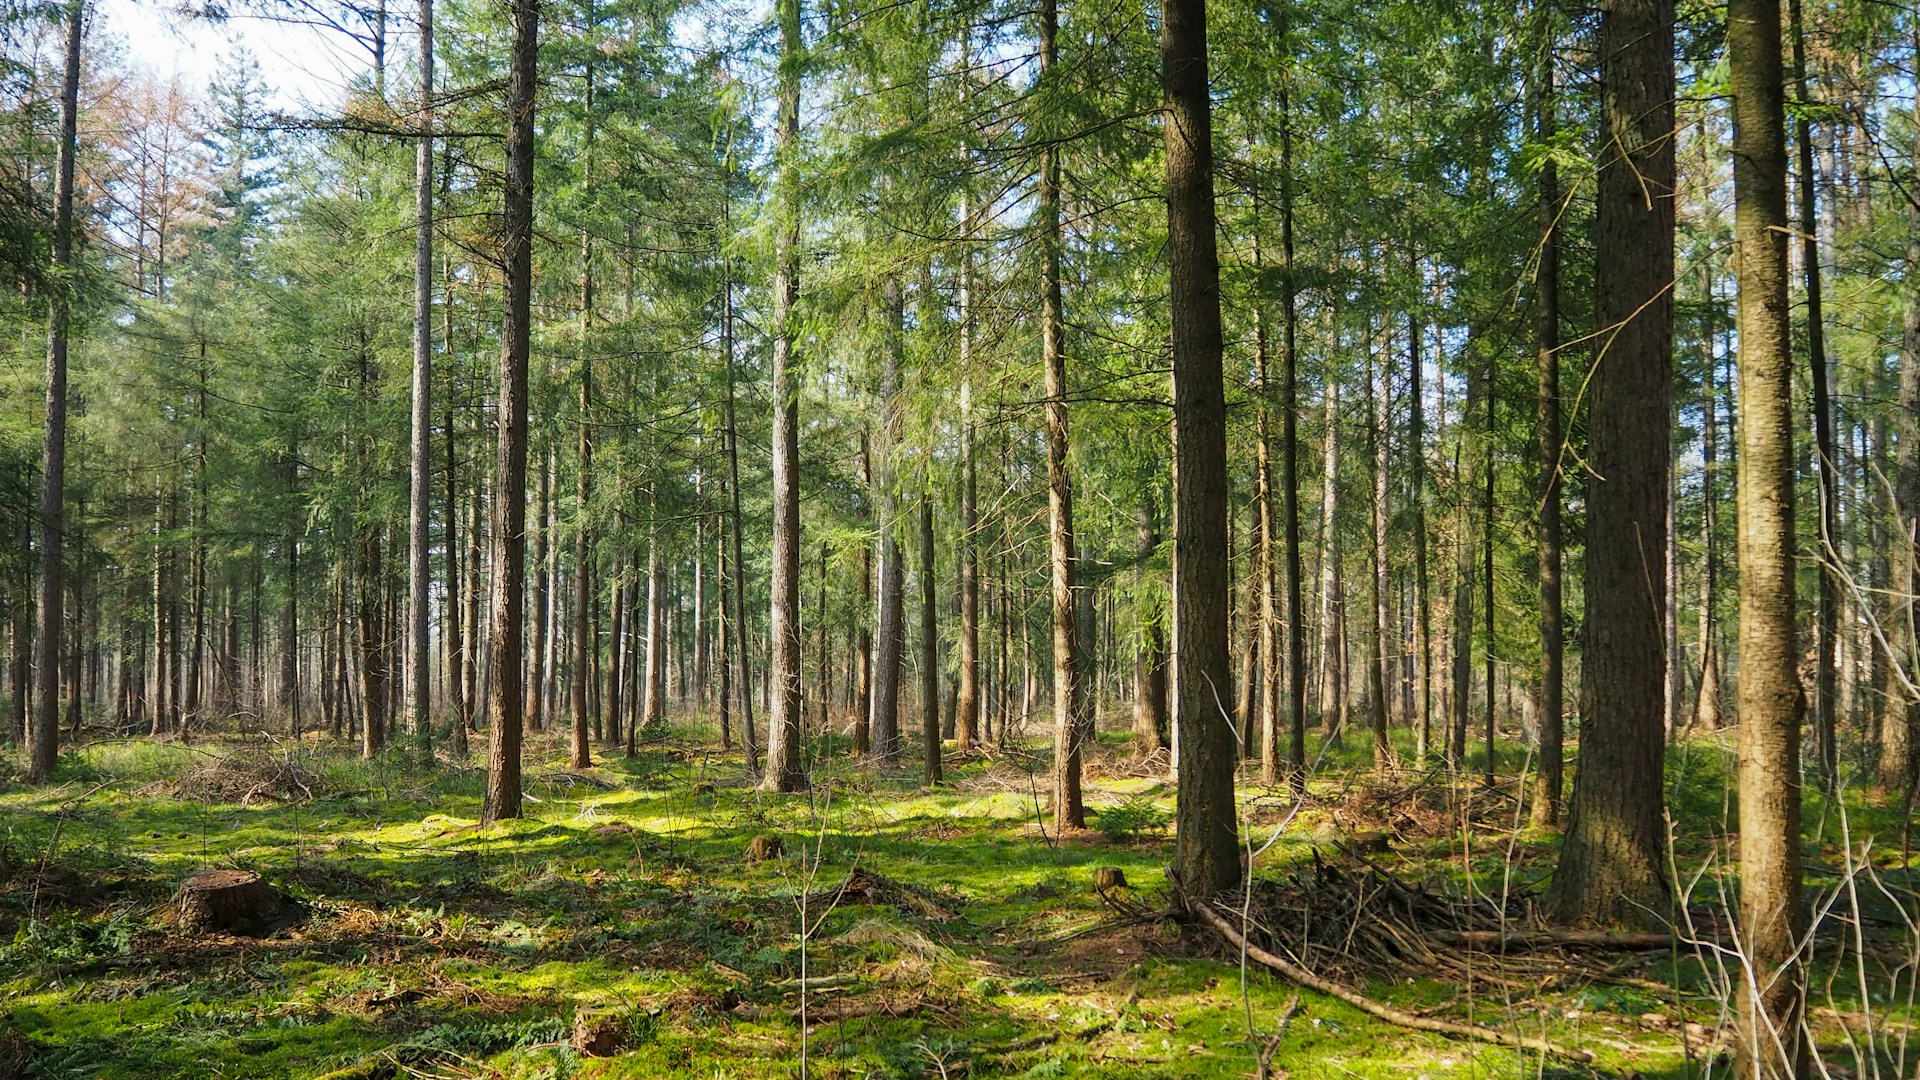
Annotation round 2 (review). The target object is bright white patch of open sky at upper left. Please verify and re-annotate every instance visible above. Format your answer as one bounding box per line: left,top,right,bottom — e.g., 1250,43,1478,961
107,0,365,113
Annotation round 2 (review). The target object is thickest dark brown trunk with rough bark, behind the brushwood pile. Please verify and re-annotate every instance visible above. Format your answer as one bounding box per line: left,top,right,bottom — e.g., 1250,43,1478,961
1553,0,1674,924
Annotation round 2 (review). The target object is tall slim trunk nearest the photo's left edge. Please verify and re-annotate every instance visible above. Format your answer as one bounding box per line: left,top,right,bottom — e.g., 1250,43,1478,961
27,0,86,784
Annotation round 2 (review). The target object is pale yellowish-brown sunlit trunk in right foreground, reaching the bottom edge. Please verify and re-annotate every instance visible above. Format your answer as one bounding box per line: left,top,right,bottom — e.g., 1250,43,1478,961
1726,0,1797,1060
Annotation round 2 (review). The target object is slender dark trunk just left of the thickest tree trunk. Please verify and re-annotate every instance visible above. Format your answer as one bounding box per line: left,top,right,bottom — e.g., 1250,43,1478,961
1532,14,1567,826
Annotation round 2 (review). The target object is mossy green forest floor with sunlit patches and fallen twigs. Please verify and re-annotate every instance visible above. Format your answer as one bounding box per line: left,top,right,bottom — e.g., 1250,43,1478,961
0,714,1920,1080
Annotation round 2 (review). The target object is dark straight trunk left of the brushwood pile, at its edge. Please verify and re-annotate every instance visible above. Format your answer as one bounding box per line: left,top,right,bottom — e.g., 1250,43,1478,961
1160,0,1240,896
